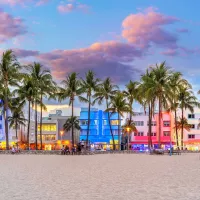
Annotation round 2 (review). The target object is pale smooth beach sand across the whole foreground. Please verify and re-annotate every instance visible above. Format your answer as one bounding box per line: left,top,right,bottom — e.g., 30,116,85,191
0,154,200,200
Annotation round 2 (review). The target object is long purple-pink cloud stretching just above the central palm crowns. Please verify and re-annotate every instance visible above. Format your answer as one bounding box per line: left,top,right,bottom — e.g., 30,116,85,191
37,41,142,82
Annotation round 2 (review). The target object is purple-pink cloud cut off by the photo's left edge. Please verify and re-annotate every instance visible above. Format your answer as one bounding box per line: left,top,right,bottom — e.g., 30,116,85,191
0,10,27,43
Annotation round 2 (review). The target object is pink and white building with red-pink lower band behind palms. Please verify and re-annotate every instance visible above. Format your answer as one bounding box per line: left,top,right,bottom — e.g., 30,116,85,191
131,112,176,149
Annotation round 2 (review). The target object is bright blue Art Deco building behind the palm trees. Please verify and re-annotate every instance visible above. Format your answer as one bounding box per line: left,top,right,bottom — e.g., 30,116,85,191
80,108,121,148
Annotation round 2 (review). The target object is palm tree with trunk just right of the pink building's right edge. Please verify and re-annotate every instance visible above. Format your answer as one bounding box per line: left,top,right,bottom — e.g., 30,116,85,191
168,72,191,147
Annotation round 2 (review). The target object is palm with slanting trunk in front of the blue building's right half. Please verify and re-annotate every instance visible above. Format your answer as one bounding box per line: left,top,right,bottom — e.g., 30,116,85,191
93,78,119,150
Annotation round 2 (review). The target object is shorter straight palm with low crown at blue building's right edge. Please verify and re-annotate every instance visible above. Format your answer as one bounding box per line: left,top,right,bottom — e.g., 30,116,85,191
105,92,131,150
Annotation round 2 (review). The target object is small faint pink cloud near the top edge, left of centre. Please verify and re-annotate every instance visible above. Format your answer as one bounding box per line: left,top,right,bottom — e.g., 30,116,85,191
57,1,89,13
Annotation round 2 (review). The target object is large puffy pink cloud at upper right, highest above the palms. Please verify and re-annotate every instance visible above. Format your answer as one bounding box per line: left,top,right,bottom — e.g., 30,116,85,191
122,8,179,48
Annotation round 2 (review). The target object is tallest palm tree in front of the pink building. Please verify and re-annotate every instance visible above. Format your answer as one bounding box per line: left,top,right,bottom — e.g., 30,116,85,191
151,62,172,148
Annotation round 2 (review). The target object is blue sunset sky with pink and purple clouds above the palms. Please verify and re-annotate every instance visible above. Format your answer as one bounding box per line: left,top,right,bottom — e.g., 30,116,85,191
0,0,200,101
